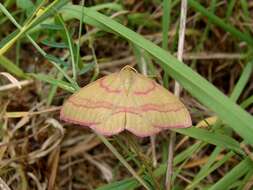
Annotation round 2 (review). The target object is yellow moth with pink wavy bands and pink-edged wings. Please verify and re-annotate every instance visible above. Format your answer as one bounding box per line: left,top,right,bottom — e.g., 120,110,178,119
60,66,192,137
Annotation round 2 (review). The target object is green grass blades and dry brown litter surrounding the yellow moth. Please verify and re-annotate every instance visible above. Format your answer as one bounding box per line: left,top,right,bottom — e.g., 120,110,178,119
0,0,253,190
